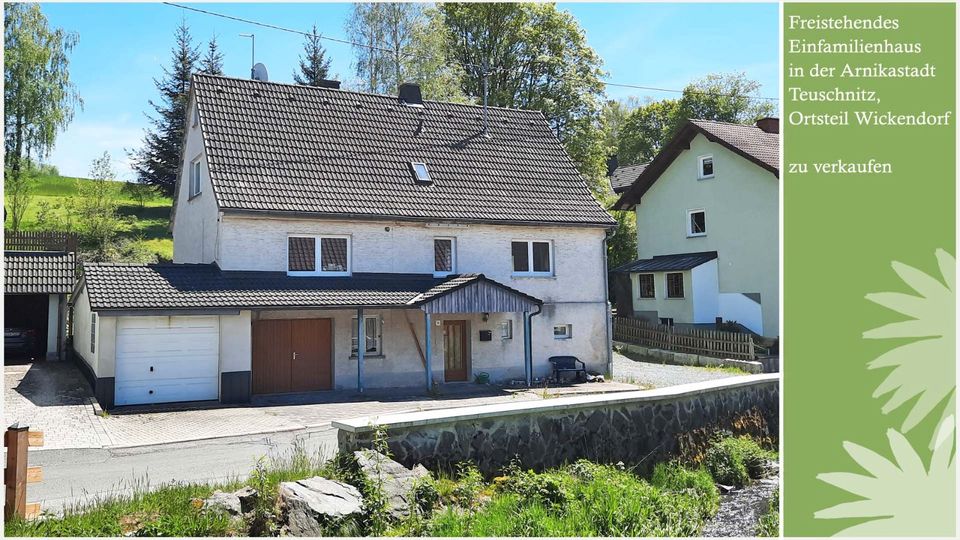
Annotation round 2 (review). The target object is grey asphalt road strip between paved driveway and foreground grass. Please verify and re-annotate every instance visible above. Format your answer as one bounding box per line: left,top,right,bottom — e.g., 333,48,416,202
27,426,337,513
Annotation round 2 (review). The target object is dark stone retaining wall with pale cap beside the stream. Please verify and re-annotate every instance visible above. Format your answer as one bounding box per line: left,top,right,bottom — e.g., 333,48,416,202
333,375,780,475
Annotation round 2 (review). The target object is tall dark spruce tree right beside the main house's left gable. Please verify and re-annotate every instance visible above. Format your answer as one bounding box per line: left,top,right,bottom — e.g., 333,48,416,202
131,20,200,196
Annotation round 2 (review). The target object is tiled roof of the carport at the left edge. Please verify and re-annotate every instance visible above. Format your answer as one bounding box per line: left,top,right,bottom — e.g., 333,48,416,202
3,251,76,294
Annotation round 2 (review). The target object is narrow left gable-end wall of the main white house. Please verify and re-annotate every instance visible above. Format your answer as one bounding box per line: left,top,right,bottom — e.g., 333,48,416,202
173,100,218,263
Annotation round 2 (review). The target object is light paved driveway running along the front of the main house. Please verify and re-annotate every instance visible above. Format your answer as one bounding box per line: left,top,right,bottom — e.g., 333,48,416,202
4,362,637,449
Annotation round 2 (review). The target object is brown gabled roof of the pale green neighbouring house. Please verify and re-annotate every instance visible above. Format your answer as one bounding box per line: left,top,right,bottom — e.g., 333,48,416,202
612,120,780,210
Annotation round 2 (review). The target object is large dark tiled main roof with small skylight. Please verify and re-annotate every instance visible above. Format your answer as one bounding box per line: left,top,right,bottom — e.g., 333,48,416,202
193,74,614,226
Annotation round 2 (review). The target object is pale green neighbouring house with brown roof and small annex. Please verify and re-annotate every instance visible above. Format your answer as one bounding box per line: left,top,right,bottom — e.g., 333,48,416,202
614,118,780,337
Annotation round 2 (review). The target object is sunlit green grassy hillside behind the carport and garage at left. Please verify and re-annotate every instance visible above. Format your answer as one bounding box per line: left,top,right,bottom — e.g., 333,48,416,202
4,175,173,261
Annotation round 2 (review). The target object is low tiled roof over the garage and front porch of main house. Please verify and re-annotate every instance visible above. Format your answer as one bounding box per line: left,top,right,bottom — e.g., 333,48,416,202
80,263,541,311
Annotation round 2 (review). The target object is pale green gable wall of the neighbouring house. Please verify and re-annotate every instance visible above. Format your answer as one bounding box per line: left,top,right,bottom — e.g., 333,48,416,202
634,135,780,336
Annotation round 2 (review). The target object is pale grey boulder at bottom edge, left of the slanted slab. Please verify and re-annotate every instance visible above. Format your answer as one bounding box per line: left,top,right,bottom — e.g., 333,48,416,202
279,476,363,536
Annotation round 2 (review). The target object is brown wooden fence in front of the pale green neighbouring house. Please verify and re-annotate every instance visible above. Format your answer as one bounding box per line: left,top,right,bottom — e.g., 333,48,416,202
613,317,756,360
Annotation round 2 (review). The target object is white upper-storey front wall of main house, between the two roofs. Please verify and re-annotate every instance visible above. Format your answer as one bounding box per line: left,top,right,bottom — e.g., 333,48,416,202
217,215,606,303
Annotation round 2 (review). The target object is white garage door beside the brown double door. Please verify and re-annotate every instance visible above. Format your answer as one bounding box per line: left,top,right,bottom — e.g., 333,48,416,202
114,317,220,405
